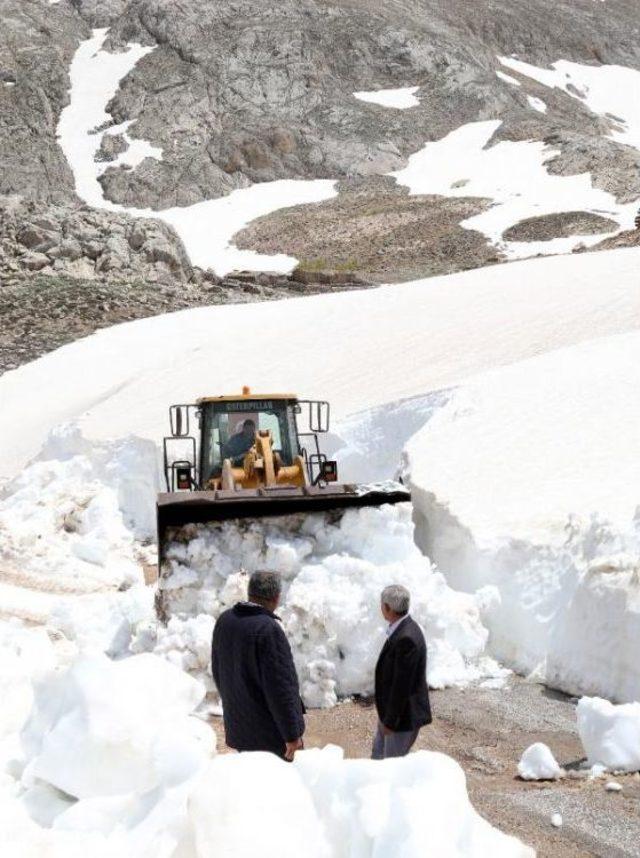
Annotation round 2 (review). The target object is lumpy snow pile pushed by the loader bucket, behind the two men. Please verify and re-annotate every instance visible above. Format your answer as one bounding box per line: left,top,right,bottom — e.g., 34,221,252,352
160,504,500,706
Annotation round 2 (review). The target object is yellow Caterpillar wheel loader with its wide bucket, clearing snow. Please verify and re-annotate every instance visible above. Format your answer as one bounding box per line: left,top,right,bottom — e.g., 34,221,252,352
156,387,410,619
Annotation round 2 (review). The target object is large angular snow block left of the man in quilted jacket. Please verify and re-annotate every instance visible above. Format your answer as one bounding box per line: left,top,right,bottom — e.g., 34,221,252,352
22,654,215,798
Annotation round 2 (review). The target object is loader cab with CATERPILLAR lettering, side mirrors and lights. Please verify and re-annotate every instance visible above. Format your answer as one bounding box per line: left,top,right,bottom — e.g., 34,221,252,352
164,388,337,492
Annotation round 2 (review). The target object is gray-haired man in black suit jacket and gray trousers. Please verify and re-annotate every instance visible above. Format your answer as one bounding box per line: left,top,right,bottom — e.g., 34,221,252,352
371,584,431,760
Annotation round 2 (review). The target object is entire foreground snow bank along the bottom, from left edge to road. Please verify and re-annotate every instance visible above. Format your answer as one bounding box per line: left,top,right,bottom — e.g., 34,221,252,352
0,644,533,858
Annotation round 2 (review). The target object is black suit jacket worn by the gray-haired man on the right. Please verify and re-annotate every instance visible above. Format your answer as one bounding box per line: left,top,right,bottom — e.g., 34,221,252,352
376,617,431,733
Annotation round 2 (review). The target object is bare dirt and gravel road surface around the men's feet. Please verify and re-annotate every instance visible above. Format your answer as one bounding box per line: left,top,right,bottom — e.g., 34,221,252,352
214,678,640,858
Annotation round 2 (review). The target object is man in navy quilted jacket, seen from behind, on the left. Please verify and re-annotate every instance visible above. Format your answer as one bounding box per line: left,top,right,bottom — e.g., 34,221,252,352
211,572,304,760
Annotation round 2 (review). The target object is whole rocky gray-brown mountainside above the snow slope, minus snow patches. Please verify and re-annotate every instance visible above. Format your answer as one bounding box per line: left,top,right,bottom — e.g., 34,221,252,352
0,0,640,367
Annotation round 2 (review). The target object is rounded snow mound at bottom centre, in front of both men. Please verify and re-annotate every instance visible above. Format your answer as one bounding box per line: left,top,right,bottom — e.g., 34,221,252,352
181,745,534,858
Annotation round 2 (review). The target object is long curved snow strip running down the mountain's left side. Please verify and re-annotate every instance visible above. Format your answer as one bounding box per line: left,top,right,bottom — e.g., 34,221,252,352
57,29,337,275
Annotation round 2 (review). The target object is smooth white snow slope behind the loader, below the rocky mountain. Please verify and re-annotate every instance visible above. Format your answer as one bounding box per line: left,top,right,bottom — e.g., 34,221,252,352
0,249,640,476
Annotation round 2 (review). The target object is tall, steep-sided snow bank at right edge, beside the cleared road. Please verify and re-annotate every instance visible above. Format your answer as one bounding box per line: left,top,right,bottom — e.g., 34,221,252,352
406,334,640,700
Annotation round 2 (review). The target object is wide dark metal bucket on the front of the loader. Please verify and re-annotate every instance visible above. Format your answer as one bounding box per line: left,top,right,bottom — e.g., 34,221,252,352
156,482,411,621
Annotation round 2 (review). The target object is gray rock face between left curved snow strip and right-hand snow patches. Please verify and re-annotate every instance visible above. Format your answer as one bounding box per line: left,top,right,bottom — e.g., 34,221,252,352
90,0,640,208
